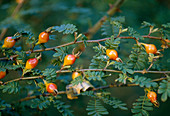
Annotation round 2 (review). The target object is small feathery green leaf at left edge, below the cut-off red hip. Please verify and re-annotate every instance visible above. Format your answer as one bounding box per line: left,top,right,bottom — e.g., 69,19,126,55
0,82,19,94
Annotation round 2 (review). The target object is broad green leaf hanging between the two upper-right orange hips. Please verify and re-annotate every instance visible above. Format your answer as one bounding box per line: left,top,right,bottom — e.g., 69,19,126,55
127,44,148,69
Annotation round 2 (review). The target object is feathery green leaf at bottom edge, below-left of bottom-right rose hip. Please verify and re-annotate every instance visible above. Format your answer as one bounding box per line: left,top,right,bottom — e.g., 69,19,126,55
131,96,153,116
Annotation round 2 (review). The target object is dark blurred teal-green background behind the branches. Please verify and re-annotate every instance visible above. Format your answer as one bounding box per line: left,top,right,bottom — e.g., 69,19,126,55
0,0,170,116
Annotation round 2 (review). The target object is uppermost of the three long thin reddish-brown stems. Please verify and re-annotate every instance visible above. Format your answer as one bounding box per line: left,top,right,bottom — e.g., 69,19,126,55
0,35,165,60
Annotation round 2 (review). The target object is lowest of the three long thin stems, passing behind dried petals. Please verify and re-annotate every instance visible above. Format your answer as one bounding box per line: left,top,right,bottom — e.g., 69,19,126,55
19,78,167,102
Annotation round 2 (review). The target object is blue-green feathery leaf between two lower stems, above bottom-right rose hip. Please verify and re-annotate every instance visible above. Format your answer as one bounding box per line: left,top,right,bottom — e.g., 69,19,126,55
132,75,158,88
